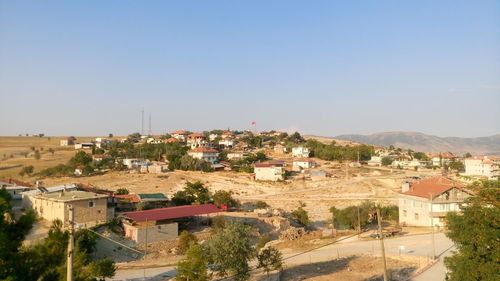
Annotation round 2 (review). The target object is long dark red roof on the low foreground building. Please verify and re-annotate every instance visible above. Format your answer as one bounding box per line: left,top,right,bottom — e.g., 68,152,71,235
123,204,221,222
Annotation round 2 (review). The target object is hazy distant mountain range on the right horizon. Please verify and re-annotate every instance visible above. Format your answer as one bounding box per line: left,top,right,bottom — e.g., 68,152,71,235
335,132,500,155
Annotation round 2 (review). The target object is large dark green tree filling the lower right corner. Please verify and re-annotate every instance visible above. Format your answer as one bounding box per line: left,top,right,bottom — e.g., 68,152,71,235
445,180,500,281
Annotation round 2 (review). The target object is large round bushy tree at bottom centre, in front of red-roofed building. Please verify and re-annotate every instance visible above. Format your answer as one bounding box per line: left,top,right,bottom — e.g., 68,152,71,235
207,222,254,281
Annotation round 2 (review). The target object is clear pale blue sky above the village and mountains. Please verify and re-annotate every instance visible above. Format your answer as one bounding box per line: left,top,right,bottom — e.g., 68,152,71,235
0,0,500,137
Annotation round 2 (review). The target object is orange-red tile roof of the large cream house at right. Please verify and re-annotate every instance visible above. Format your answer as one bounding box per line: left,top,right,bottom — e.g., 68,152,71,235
402,177,463,199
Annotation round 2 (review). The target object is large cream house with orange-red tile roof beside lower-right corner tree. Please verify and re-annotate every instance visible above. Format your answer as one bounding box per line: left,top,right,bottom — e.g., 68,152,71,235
399,177,472,227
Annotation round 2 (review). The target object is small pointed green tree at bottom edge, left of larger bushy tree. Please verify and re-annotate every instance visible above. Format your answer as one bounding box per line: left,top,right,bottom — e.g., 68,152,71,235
175,243,209,281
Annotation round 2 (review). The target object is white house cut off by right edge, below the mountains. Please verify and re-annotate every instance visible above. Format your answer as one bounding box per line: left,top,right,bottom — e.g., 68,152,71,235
463,156,500,179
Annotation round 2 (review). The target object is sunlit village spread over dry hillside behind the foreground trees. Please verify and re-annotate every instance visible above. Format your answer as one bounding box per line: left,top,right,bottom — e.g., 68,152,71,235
0,130,500,280
